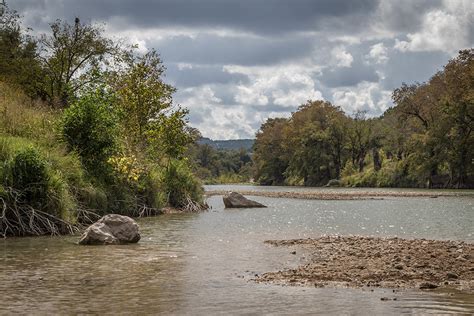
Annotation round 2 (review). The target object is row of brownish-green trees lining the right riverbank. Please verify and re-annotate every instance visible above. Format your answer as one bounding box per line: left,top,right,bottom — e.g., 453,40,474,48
253,49,474,188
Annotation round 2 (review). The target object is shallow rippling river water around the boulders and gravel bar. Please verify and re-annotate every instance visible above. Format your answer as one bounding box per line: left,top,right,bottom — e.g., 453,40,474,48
0,186,474,315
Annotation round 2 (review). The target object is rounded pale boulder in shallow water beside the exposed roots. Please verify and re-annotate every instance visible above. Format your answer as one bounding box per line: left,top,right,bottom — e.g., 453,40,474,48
79,214,140,245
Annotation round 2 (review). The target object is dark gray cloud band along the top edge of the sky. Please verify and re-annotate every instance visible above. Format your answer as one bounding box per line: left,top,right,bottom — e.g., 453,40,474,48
14,0,377,34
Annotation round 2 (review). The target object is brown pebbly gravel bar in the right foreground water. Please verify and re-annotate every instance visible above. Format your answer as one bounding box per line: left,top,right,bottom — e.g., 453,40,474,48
254,236,474,293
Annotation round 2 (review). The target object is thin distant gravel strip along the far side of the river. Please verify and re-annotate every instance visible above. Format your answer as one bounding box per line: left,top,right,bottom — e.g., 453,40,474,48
205,190,474,200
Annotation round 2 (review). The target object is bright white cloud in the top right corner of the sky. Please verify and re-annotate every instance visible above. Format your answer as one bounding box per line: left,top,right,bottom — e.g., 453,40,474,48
394,0,474,53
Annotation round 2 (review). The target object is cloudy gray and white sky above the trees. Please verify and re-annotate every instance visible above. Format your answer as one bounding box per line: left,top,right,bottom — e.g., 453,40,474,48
7,0,474,139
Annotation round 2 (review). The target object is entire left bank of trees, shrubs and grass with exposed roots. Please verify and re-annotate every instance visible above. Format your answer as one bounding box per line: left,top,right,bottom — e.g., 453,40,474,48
0,1,205,236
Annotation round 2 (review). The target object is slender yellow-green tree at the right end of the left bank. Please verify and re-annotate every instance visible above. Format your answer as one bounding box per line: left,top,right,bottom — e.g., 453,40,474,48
110,50,193,158
